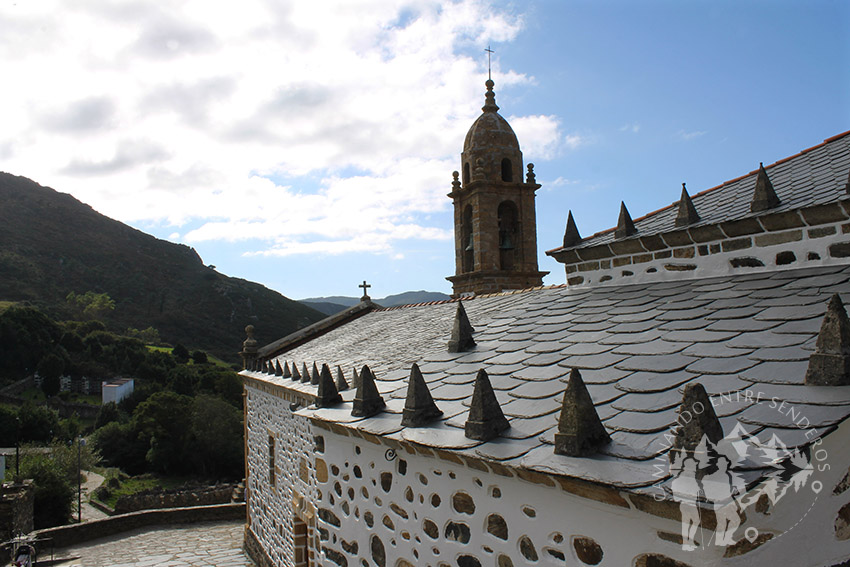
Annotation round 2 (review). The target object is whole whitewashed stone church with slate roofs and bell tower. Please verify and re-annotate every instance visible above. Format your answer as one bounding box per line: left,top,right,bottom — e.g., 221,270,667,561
241,76,850,567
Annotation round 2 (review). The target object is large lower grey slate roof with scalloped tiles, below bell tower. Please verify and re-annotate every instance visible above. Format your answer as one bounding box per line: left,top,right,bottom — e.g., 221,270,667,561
246,264,850,491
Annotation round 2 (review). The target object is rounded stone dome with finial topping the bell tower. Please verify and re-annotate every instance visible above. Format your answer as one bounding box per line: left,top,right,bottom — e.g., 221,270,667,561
461,79,522,184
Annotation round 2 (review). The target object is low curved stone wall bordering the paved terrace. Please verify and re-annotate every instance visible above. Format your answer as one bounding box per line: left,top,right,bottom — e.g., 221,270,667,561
33,502,245,548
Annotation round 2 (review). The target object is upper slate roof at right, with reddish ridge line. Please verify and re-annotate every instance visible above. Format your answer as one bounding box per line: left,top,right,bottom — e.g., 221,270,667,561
549,132,850,253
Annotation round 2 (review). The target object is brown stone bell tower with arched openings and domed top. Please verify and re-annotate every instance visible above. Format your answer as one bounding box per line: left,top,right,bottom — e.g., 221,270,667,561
446,79,549,296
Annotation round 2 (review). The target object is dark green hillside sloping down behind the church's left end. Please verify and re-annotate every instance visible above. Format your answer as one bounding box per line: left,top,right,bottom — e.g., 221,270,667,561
0,173,324,361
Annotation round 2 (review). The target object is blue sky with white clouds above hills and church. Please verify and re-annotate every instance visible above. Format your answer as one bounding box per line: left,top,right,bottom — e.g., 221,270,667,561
0,0,850,298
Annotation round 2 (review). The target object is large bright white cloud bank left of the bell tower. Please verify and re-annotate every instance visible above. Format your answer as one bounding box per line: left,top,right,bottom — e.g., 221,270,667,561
0,0,552,255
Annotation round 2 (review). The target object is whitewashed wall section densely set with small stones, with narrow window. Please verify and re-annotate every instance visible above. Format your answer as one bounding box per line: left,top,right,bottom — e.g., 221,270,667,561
245,384,316,567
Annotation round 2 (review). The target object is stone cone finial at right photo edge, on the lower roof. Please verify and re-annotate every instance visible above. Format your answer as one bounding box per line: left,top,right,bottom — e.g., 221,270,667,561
806,293,850,386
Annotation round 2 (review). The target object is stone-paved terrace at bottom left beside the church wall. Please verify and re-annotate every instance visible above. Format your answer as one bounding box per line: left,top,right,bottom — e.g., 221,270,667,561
51,521,254,567
